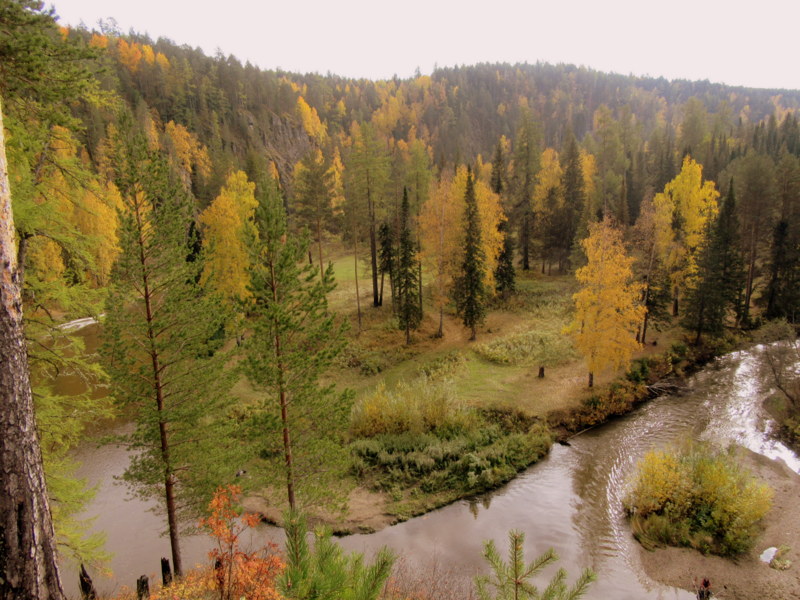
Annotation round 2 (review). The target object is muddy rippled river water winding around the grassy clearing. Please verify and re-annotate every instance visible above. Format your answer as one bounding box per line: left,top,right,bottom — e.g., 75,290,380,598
57,326,800,600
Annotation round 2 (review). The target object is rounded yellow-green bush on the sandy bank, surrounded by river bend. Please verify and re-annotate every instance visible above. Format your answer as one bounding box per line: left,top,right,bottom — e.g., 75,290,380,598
625,444,772,556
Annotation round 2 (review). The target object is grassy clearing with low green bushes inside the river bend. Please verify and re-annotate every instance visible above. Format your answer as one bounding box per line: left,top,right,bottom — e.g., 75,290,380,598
233,255,692,519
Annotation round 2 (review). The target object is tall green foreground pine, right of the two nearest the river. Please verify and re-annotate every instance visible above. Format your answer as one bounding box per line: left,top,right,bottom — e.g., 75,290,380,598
242,175,349,509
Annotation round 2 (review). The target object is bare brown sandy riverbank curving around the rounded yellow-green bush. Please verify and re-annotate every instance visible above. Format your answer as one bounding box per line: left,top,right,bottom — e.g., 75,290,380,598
639,449,800,600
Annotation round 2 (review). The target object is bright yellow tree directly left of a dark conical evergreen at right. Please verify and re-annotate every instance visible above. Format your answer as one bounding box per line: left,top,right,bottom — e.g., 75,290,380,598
653,156,719,315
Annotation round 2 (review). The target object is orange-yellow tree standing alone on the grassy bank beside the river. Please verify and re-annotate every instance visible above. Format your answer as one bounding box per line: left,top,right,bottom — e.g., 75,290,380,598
566,217,644,387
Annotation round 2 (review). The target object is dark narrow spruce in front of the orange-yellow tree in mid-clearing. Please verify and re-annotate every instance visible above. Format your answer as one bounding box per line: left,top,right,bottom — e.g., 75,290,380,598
453,169,487,341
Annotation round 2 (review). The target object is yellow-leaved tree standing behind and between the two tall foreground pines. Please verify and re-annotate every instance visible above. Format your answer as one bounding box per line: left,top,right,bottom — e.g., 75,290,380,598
199,171,258,304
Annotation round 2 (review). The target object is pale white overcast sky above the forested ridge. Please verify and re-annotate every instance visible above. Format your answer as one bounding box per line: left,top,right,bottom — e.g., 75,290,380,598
48,0,800,89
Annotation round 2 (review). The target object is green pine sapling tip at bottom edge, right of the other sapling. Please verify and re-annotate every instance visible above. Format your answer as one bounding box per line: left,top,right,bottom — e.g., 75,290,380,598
475,530,597,600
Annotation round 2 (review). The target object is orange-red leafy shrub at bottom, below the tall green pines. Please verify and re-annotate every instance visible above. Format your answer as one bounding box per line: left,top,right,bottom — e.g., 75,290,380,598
199,485,284,600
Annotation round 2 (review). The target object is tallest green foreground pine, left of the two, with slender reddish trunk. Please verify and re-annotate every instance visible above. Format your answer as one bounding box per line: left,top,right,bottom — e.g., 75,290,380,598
101,117,228,575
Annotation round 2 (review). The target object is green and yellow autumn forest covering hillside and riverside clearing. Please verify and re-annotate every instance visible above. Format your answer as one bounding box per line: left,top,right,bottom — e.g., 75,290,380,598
0,0,800,598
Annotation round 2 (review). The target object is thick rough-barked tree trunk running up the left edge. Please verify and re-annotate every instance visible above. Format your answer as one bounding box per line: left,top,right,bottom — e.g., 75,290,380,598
0,101,64,600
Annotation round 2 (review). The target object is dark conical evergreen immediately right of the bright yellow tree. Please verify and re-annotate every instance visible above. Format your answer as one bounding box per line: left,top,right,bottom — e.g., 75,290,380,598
683,182,745,344
